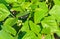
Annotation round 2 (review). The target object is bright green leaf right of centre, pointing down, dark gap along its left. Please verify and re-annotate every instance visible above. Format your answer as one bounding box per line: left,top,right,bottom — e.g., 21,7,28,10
34,8,47,24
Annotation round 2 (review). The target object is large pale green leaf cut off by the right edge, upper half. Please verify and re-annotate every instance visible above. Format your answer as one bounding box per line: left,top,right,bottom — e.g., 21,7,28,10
49,5,60,22
